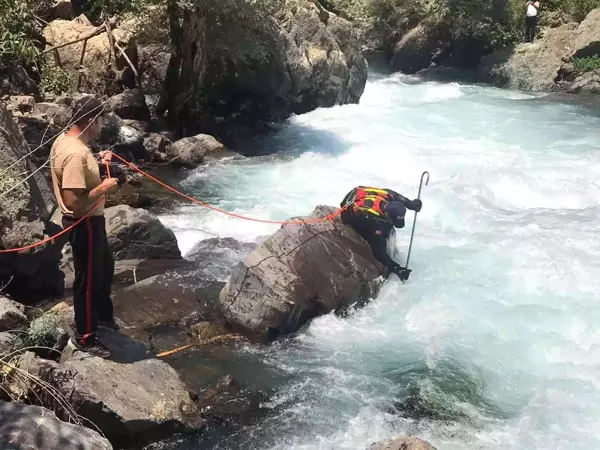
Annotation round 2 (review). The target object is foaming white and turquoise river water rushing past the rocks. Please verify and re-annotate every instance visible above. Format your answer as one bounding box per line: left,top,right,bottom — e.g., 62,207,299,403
161,75,600,450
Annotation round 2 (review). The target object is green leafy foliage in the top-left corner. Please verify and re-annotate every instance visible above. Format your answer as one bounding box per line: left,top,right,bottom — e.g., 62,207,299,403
0,0,39,63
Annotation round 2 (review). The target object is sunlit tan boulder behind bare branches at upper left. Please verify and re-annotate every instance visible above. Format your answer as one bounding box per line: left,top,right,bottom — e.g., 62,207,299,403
43,15,137,92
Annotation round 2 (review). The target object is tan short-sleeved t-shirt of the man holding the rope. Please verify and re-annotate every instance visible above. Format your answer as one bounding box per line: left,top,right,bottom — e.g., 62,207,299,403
50,134,104,218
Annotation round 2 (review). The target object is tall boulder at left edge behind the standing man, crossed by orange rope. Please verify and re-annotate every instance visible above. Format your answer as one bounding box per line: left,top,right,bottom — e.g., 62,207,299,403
0,104,62,295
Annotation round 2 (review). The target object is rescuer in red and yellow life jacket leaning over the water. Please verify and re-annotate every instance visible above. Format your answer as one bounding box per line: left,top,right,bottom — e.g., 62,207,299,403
340,186,423,281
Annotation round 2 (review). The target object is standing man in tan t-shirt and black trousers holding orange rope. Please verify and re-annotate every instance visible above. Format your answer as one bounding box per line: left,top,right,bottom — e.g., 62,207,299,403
50,96,118,358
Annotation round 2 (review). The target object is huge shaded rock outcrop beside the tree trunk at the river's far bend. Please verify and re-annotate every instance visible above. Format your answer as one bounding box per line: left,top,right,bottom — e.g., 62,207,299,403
170,0,367,143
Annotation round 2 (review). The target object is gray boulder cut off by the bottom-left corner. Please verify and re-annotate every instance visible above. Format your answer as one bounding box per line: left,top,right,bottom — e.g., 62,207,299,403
0,401,113,450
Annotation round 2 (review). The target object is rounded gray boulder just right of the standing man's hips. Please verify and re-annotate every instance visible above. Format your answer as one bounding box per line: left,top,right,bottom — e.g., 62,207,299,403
105,205,181,259
